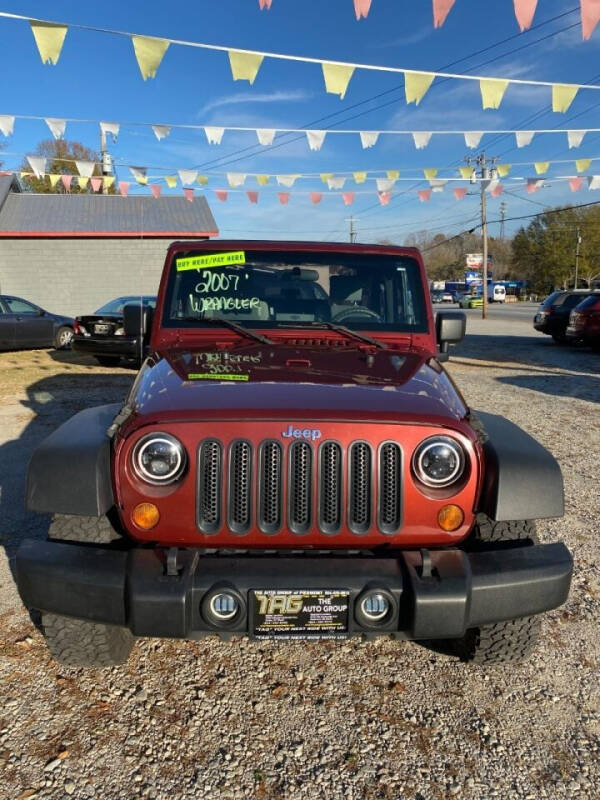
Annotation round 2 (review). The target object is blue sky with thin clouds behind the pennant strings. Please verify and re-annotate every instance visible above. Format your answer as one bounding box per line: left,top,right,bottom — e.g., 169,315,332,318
0,0,600,242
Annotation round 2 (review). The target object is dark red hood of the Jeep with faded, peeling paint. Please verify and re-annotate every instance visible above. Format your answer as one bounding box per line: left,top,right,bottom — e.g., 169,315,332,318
122,344,468,427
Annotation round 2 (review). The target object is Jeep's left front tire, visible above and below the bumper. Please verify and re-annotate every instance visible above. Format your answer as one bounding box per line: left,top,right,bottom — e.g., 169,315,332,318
42,514,134,667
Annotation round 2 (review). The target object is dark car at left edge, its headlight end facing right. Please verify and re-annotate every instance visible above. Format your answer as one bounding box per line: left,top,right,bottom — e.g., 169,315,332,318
0,294,74,350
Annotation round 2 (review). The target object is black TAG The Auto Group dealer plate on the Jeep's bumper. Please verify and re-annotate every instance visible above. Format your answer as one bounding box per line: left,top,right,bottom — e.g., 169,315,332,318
250,588,350,639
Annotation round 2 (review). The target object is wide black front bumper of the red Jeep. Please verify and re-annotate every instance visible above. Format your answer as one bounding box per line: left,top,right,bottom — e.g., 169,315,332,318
16,539,573,639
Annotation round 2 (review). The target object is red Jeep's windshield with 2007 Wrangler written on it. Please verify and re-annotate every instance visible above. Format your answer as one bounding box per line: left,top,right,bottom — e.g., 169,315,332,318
163,250,427,332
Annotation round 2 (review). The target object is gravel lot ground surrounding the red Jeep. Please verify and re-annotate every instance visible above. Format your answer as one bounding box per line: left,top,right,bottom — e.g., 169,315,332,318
0,320,600,800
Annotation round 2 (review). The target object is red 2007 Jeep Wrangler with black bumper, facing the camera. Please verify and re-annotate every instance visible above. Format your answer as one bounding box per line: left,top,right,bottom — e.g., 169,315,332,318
17,241,572,666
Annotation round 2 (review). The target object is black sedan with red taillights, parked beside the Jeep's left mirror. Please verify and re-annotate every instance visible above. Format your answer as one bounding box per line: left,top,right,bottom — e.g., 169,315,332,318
73,295,156,367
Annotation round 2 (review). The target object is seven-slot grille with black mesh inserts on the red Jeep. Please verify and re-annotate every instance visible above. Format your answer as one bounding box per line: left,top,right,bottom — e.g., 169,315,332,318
197,439,402,536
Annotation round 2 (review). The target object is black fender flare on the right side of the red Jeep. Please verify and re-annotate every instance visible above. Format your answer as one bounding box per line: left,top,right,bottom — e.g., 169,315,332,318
476,411,564,522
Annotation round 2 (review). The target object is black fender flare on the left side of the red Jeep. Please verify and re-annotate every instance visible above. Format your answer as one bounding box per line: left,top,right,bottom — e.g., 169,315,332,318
27,403,121,517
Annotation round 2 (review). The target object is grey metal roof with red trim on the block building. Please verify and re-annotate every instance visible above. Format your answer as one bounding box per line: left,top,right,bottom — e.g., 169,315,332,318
0,177,218,238
